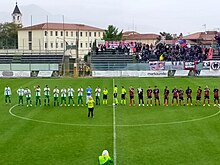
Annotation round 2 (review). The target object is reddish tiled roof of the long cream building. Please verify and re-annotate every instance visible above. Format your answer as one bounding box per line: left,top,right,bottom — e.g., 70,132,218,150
21,23,104,31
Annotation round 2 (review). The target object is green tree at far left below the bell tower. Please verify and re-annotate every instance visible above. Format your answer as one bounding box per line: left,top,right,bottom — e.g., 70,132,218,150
0,22,22,49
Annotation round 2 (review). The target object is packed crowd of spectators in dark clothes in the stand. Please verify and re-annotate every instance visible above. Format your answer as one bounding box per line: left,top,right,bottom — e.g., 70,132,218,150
93,42,209,63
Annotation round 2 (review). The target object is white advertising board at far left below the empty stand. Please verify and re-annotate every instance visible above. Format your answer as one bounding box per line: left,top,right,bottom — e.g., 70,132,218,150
0,71,31,78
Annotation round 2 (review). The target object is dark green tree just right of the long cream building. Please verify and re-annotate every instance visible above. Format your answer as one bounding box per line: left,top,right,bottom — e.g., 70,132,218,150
103,25,123,41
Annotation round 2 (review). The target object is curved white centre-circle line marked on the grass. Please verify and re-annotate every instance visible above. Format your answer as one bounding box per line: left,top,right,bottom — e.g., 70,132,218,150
9,104,220,128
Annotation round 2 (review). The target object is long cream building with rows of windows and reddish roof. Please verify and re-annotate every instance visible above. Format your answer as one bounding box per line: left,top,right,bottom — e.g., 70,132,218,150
18,23,105,58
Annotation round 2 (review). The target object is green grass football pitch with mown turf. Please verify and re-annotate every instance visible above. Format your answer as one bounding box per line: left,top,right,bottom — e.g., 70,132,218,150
0,78,220,165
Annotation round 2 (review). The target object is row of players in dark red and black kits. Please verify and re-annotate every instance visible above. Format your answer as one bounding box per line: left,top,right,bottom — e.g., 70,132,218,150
126,86,219,106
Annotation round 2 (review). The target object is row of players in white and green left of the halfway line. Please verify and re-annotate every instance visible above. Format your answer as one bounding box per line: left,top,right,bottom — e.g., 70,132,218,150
4,85,108,106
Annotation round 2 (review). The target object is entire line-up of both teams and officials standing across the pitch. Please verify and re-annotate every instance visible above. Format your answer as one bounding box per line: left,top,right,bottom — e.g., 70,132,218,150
4,85,219,105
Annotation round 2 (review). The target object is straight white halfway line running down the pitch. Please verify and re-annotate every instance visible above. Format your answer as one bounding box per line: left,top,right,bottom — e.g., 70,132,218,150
112,79,117,165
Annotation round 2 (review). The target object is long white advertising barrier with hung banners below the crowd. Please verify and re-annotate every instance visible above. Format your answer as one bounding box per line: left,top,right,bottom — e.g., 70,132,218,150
92,61,220,77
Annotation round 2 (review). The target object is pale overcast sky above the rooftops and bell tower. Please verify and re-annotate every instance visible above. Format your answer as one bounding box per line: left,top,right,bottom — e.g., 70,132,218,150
0,0,220,34
